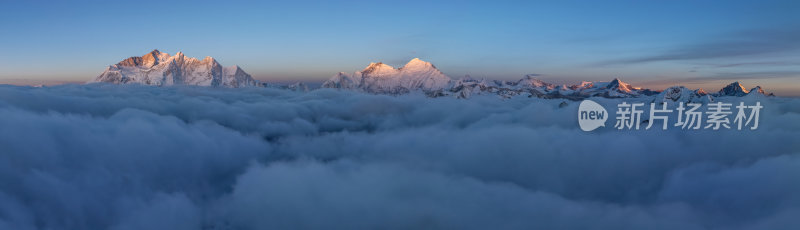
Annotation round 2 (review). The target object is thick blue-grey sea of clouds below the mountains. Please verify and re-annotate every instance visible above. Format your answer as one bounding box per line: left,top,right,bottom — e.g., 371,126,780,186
0,84,800,230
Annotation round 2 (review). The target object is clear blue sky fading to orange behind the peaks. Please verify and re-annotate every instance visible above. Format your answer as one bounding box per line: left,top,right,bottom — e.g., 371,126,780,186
0,0,800,96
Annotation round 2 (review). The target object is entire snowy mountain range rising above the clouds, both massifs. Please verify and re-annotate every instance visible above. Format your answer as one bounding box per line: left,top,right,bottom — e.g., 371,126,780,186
89,50,774,102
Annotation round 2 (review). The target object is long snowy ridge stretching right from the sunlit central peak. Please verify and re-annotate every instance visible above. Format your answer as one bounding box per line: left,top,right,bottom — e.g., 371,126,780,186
322,58,772,102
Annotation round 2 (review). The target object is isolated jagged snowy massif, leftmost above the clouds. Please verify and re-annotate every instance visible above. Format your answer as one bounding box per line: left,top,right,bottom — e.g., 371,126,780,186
90,50,258,88
